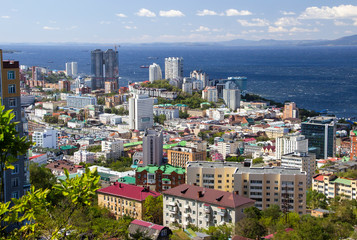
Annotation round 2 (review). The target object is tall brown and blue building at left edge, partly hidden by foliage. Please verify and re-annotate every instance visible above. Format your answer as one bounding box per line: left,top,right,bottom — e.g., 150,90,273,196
0,49,30,202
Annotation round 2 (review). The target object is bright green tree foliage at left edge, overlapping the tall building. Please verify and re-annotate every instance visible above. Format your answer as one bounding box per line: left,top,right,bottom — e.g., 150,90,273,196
0,105,32,202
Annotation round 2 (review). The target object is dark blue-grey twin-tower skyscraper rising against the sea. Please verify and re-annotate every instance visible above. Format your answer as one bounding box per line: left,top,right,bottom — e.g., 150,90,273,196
91,49,119,89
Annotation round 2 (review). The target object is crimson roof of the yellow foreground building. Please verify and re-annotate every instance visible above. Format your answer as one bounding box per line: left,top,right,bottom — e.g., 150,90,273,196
97,182,161,201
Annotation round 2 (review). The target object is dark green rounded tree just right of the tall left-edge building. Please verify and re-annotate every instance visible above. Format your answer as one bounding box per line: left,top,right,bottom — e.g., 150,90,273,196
30,163,57,189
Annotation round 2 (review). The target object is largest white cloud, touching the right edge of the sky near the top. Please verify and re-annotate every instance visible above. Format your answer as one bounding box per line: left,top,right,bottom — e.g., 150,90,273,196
299,5,357,19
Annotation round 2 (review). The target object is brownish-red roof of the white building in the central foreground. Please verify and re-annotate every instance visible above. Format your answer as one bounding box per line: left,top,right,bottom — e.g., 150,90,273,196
163,184,255,208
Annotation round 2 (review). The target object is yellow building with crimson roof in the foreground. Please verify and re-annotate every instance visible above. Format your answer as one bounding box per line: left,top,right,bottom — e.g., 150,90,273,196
97,182,160,220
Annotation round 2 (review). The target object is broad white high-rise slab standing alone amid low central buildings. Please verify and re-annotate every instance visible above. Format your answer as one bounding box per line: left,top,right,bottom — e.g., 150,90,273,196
129,94,154,131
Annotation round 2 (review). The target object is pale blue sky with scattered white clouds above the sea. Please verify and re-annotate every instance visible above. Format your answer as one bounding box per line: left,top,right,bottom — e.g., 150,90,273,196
0,0,357,43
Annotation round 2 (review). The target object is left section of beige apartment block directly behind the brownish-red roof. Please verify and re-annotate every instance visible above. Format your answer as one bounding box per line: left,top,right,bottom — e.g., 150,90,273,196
186,161,242,192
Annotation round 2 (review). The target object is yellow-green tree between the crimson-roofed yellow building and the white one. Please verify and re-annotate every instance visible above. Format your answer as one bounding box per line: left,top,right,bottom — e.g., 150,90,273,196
144,195,163,225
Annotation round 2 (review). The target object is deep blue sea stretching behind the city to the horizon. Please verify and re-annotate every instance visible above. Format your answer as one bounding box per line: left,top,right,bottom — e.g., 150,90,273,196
0,44,357,118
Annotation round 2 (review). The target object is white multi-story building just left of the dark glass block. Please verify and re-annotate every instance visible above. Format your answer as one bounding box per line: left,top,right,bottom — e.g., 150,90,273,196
275,133,309,160
